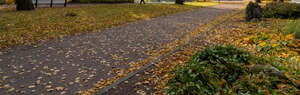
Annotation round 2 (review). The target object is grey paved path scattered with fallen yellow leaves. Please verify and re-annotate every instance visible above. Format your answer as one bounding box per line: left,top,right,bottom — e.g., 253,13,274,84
0,4,242,95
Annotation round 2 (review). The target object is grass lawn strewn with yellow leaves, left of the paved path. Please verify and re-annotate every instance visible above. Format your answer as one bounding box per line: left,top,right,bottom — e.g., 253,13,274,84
0,4,197,49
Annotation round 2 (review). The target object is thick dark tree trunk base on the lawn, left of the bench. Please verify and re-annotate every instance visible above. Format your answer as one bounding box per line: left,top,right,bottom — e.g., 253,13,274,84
16,0,34,10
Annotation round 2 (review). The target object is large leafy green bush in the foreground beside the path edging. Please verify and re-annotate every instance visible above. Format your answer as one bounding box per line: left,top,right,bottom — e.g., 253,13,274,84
166,45,254,95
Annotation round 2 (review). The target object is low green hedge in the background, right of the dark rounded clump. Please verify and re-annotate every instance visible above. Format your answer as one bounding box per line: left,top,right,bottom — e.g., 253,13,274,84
263,3,300,18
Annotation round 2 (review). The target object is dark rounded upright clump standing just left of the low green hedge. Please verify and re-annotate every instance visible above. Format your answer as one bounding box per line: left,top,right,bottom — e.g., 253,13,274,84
246,2,262,21
